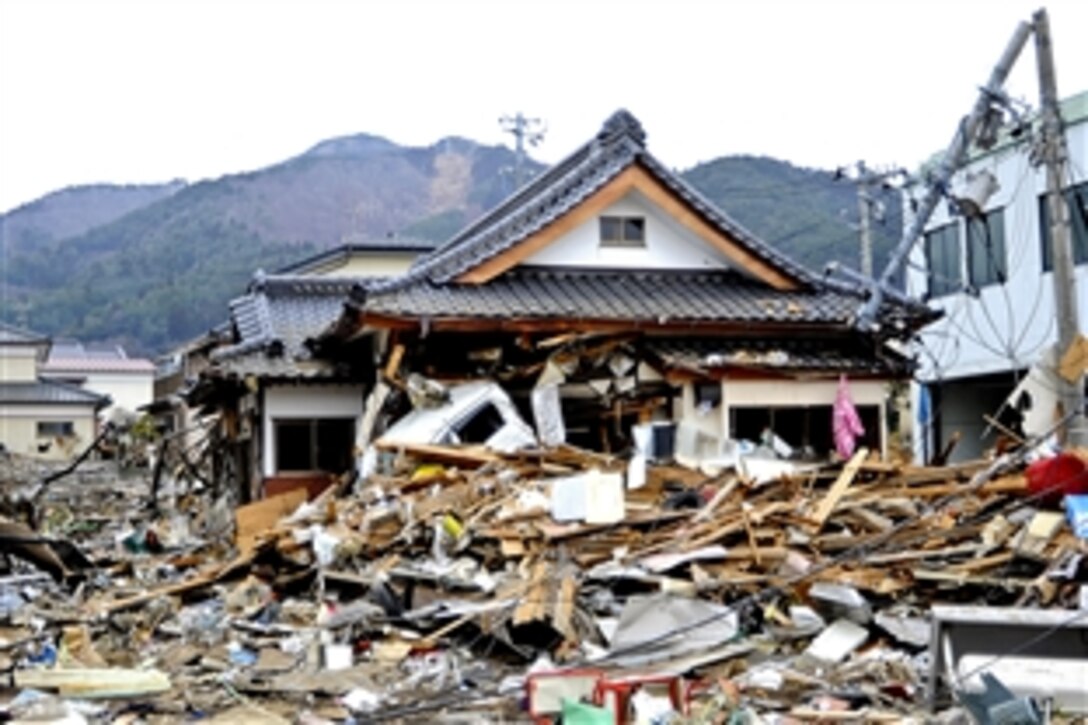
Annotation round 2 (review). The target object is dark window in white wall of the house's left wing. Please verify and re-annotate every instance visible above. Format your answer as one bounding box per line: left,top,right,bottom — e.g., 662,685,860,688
274,418,355,474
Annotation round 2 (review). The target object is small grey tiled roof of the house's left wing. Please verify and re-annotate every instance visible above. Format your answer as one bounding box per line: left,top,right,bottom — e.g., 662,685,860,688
211,275,369,377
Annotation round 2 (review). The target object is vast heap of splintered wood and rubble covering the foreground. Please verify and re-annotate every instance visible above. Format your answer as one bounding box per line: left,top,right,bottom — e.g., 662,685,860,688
0,426,1088,723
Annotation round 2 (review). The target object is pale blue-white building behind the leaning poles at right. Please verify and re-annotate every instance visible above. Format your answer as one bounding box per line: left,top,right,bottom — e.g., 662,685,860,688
906,91,1088,460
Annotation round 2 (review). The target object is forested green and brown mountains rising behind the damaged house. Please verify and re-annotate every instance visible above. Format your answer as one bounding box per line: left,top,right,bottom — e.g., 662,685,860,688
0,134,895,354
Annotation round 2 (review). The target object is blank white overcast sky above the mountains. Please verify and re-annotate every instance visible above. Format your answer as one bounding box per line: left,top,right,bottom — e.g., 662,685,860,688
0,0,1088,211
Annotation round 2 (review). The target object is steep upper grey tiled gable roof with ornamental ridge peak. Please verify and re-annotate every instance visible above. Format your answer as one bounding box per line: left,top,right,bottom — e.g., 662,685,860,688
382,110,813,287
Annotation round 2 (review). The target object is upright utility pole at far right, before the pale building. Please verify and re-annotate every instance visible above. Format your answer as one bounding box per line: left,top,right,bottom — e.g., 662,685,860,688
1031,10,1088,446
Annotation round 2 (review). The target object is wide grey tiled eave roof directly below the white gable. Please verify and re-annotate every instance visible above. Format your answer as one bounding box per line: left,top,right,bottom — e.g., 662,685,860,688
354,267,858,323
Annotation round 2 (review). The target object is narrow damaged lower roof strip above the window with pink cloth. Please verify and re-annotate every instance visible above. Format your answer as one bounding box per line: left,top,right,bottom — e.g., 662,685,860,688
646,336,913,374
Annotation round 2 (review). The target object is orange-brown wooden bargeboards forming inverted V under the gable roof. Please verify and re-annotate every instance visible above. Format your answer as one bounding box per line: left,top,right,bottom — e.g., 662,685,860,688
457,164,801,291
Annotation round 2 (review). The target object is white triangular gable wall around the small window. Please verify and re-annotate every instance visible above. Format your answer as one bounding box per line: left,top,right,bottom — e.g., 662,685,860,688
522,191,729,269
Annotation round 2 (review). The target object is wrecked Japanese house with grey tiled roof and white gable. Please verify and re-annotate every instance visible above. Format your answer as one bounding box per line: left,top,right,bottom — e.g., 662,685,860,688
197,111,930,495
